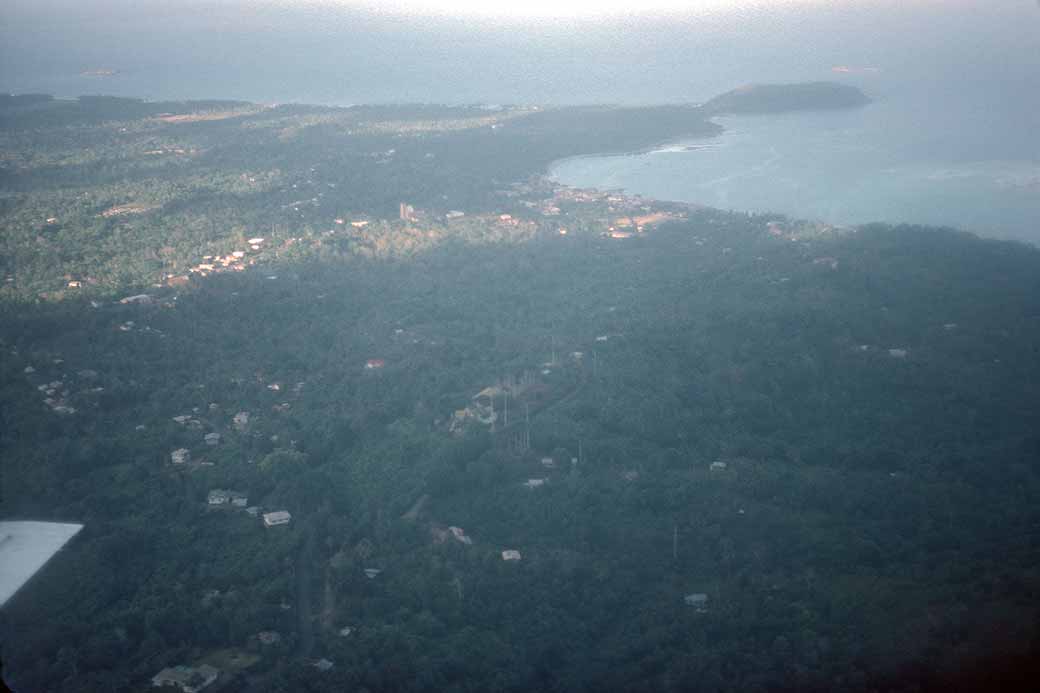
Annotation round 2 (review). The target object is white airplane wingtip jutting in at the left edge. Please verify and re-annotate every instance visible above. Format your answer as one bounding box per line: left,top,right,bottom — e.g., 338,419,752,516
0,522,83,607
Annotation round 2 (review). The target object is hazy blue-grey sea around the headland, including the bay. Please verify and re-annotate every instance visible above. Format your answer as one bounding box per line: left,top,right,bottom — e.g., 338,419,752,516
0,0,1040,242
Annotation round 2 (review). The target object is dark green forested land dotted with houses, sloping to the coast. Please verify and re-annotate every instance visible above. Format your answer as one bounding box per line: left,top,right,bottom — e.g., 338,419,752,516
0,91,1040,693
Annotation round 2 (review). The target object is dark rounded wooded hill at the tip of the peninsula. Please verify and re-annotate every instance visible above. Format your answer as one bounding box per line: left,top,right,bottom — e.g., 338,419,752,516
702,82,870,116
